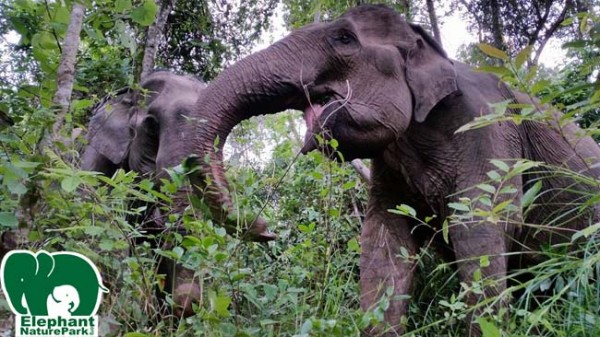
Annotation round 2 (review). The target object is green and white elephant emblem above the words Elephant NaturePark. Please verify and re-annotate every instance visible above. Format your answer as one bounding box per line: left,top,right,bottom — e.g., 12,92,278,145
0,250,108,317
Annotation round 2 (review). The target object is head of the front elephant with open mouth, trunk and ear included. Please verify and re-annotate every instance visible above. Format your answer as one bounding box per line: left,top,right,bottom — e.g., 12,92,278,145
196,6,457,226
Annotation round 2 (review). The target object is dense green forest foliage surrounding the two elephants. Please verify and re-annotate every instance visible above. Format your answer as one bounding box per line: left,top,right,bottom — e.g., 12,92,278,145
0,0,600,337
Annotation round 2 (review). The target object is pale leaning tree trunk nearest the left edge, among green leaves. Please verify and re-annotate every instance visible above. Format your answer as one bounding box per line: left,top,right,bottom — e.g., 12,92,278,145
42,2,85,147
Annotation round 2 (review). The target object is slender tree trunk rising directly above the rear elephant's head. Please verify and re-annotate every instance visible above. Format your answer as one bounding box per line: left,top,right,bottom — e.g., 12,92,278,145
140,0,177,81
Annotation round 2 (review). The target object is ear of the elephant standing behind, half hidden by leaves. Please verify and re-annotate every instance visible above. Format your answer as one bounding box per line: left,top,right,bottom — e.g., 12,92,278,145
88,91,132,165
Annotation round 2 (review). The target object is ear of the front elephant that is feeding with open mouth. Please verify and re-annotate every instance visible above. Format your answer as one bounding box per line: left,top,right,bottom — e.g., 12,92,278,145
406,24,458,123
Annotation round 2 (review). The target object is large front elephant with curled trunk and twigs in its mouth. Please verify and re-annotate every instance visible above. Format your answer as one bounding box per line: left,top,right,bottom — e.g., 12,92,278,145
185,5,600,336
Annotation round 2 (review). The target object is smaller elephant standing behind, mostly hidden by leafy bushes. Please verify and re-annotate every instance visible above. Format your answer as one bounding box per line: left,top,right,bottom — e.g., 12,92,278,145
82,71,275,316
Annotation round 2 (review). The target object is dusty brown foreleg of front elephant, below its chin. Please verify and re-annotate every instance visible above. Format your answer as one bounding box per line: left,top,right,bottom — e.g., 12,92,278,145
360,209,418,336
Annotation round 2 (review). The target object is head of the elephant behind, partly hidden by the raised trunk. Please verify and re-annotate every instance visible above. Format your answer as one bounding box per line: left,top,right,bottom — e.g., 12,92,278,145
82,71,205,175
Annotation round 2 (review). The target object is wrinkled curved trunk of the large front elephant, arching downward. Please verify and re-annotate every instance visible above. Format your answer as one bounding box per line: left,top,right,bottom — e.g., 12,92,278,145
195,37,322,239
